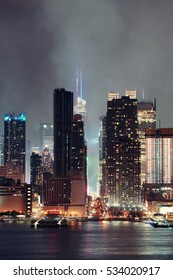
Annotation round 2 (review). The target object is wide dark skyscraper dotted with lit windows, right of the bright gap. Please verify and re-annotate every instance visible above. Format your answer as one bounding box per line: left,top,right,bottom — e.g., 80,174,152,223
106,96,141,205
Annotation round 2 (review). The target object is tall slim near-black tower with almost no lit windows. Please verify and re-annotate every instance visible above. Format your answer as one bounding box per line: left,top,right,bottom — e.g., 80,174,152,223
54,88,73,177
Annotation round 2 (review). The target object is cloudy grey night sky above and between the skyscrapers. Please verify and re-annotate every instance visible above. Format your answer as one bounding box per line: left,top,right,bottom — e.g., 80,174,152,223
0,0,173,190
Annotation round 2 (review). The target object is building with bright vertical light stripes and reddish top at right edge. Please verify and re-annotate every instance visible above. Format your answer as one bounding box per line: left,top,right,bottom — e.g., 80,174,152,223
145,128,173,199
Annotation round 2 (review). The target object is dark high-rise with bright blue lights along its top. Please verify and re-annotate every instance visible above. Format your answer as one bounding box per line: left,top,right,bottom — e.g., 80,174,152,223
4,113,26,182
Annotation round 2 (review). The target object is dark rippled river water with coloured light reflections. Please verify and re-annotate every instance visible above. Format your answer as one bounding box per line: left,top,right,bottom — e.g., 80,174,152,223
0,221,173,260
